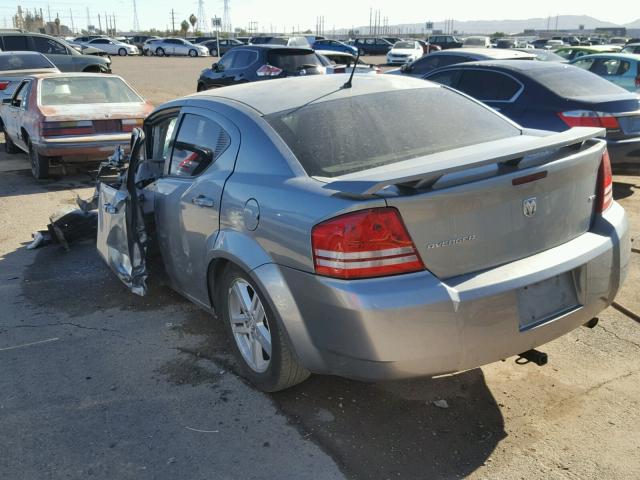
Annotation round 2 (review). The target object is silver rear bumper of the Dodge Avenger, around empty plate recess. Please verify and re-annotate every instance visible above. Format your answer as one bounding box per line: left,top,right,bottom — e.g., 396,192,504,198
253,203,630,381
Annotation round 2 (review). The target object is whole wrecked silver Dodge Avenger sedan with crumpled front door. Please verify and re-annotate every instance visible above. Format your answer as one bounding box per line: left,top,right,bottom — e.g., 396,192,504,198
98,75,630,391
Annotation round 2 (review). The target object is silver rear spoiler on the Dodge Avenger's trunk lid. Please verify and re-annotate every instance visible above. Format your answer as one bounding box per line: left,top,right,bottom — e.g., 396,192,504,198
323,127,606,196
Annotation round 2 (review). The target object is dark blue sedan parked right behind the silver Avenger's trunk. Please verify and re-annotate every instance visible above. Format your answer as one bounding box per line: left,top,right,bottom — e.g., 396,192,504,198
423,60,640,168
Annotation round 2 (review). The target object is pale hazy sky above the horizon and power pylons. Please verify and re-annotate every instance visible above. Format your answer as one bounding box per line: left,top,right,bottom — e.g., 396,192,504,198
0,0,640,31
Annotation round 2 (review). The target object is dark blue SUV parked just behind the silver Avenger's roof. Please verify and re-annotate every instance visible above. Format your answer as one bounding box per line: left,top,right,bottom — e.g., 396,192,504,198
197,45,325,92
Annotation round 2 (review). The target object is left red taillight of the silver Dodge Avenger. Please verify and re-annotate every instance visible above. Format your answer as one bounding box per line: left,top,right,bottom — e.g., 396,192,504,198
311,207,424,279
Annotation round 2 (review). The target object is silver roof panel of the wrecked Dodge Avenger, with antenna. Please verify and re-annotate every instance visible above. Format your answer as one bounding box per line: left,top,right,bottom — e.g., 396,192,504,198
182,74,439,115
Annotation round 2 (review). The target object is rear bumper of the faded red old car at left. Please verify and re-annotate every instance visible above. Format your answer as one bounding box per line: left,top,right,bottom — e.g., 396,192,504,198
34,133,131,162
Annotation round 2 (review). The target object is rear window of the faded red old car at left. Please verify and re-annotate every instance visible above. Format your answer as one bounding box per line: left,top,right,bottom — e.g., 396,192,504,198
40,76,143,105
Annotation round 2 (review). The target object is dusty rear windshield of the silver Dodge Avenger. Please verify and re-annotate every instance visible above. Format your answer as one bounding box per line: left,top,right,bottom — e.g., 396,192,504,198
265,88,520,177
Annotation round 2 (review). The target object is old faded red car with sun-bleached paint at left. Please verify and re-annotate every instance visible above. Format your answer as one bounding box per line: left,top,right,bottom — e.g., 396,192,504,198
0,73,153,179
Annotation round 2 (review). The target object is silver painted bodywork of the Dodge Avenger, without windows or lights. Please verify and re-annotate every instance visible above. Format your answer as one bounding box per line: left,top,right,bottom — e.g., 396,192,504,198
97,76,630,380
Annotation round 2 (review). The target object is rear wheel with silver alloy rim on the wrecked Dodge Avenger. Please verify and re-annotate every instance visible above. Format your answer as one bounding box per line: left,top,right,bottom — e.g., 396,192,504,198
216,265,310,392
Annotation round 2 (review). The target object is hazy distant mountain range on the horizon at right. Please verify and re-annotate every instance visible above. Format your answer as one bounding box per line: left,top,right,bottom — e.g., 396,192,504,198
344,15,640,34
